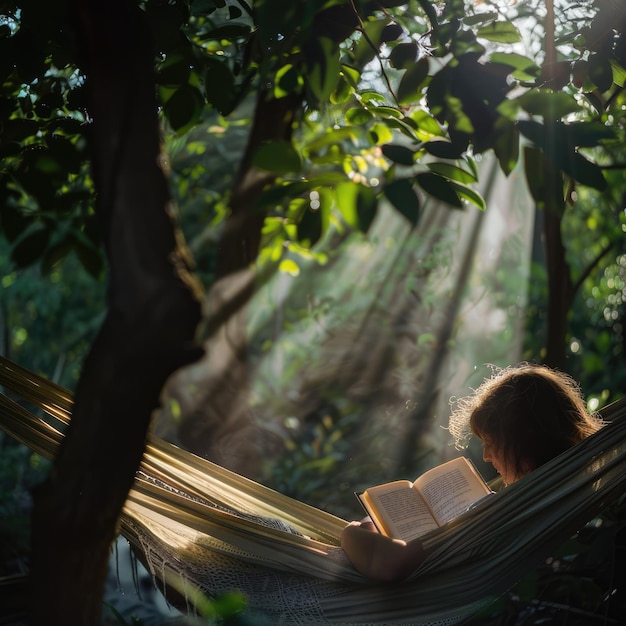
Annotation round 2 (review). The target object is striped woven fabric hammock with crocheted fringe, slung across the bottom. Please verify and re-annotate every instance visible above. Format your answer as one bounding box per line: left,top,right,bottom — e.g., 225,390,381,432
0,358,626,626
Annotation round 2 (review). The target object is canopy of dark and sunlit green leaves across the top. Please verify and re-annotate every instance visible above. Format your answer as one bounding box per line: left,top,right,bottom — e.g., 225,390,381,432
0,0,624,273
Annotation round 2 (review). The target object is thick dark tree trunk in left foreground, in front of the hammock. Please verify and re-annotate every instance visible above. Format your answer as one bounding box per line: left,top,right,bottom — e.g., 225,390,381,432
30,0,201,626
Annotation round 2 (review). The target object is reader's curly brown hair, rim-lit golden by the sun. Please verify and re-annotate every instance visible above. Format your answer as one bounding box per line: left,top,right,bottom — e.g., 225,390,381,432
449,363,604,475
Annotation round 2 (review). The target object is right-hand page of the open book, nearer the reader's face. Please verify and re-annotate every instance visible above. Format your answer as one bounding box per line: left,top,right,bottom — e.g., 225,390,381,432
415,457,491,525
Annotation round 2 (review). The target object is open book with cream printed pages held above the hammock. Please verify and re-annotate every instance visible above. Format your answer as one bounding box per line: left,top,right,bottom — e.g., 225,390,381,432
356,457,492,541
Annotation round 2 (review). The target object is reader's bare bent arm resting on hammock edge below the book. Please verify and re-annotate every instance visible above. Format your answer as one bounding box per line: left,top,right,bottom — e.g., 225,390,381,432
341,522,424,581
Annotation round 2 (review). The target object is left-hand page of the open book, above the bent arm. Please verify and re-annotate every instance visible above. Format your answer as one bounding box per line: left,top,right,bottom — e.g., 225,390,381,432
361,480,437,541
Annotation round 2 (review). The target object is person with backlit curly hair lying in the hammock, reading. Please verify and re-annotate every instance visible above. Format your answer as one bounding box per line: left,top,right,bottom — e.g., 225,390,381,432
341,363,603,581
